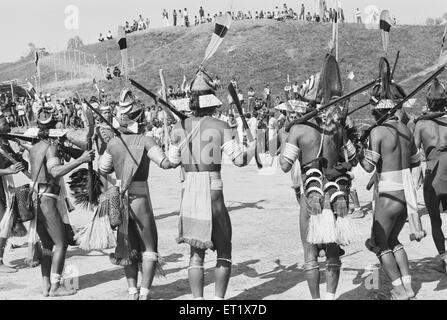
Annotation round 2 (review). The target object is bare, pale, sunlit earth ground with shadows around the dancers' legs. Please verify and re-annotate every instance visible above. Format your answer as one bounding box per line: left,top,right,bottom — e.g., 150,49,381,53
0,160,447,300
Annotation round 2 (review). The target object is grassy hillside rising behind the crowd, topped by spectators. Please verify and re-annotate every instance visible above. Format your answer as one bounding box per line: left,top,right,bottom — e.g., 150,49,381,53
0,20,447,118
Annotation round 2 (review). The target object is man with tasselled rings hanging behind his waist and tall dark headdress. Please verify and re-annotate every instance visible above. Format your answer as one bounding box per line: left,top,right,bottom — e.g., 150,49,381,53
279,54,356,300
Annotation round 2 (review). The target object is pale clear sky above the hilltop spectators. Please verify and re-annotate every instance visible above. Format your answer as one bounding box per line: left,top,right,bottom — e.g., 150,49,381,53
0,0,447,63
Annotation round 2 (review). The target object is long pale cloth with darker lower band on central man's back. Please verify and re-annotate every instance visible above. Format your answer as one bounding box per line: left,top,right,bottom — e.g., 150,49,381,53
177,171,223,250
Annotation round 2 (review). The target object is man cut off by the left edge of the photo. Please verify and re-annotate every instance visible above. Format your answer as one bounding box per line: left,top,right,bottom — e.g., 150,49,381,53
0,114,25,273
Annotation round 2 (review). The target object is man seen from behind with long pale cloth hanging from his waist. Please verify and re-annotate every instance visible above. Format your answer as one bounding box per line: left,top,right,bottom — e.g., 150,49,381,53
169,67,256,300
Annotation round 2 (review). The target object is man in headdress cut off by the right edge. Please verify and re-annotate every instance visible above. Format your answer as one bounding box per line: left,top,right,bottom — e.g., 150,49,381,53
414,79,447,272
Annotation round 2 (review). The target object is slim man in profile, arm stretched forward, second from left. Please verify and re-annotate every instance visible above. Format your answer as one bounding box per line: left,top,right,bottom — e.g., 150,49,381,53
28,107,94,297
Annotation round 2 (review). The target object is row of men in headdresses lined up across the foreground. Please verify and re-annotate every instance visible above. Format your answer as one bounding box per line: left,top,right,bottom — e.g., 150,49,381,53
0,47,447,300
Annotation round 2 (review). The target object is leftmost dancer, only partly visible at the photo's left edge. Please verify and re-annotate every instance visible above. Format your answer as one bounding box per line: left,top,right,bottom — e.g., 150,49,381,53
0,114,25,273
